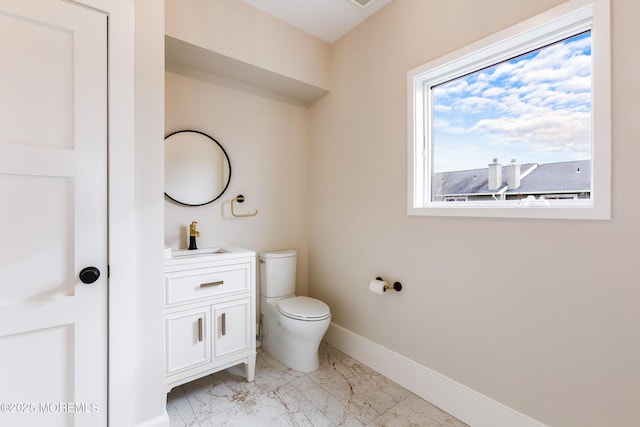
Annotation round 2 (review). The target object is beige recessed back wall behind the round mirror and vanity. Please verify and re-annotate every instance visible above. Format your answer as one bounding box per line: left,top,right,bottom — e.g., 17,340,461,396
165,69,309,295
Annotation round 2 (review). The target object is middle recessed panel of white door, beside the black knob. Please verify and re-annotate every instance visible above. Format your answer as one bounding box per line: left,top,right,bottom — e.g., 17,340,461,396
0,175,75,304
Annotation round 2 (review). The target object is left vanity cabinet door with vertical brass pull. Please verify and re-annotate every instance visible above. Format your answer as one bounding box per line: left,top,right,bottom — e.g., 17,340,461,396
166,307,211,375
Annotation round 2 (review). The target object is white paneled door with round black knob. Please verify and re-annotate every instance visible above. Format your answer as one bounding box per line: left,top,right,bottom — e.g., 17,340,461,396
0,0,107,427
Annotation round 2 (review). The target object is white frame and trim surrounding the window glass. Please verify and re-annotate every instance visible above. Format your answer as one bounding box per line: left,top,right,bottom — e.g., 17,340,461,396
407,0,611,220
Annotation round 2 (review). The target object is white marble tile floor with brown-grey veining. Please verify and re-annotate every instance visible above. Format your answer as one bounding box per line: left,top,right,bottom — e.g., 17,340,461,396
167,342,466,427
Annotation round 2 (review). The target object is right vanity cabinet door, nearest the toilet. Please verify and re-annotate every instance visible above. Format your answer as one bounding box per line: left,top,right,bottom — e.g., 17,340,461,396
213,298,251,360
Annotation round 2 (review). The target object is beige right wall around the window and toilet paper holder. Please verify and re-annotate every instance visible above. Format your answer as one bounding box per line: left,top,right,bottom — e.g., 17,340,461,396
309,0,640,427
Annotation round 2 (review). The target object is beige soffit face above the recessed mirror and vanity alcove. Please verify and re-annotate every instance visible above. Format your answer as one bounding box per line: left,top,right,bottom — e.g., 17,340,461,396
165,0,330,88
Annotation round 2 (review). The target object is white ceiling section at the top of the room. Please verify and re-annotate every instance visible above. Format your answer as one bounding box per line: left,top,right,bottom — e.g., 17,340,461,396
243,0,392,43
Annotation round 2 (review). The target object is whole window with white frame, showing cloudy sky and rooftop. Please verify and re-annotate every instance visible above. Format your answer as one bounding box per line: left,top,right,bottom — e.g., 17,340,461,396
408,0,611,219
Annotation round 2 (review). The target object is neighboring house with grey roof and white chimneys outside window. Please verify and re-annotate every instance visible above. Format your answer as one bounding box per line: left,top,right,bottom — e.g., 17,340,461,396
432,159,591,202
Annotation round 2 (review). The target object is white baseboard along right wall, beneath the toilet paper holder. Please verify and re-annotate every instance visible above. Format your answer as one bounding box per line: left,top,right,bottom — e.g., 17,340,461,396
324,323,547,427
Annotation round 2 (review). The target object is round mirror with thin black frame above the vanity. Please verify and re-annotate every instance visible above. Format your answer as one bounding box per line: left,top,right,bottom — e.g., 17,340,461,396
164,130,231,206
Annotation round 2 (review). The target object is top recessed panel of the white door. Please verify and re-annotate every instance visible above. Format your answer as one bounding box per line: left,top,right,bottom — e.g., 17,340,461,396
0,9,74,148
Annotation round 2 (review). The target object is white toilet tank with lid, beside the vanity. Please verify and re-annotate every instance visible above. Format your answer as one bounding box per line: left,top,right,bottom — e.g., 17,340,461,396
260,249,298,298
